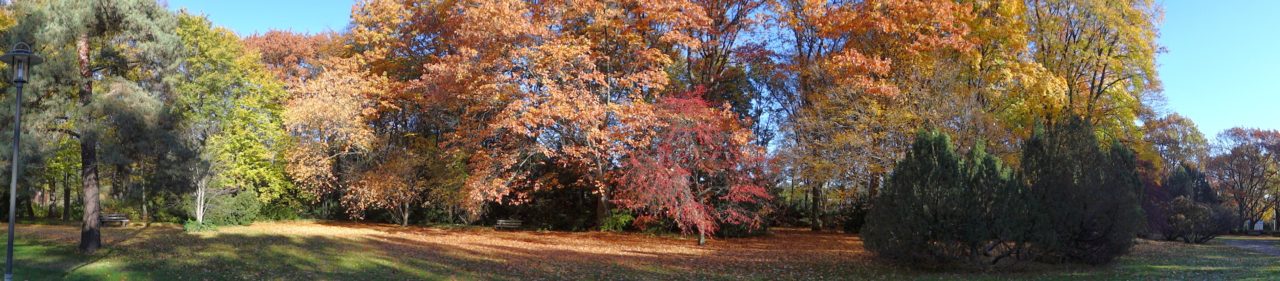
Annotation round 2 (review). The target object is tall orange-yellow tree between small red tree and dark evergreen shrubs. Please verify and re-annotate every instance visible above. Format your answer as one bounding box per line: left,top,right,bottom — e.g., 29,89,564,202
771,0,972,230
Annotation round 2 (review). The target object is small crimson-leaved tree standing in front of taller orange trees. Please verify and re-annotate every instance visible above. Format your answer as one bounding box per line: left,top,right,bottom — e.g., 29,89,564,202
613,87,772,244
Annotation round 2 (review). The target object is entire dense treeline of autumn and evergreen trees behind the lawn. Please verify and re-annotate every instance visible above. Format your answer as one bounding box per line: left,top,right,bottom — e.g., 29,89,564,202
0,0,1280,269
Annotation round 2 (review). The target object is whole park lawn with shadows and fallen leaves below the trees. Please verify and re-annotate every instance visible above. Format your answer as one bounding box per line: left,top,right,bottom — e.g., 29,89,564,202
0,222,1280,280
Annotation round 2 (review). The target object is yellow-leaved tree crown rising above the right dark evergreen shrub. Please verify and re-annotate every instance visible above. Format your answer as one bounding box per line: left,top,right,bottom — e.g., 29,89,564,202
1027,0,1161,141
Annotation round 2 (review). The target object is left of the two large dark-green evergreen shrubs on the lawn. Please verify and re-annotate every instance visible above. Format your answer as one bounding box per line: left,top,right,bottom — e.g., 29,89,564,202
861,132,1032,268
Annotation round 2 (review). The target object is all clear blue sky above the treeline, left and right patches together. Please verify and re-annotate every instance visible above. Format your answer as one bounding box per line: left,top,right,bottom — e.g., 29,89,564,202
168,0,1280,139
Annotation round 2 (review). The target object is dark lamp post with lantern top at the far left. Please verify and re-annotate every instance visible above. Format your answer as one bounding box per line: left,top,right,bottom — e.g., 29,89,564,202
0,42,45,281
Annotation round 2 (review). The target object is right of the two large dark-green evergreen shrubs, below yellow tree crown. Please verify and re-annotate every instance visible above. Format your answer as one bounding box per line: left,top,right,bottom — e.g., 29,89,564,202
1023,118,1146,264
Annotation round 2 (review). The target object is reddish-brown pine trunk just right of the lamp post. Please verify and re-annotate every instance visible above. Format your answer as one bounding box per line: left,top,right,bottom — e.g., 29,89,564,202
76,33,102,254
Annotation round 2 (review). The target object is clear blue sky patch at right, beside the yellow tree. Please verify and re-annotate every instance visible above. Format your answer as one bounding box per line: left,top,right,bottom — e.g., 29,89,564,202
1157,0,1280,139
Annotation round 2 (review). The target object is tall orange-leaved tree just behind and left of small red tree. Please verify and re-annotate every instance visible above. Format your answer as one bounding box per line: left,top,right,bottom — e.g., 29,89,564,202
468,1,707,226
